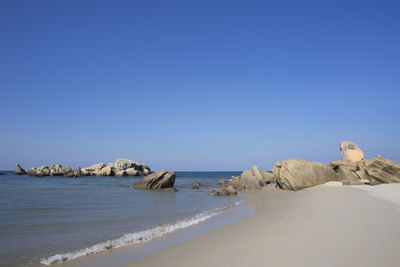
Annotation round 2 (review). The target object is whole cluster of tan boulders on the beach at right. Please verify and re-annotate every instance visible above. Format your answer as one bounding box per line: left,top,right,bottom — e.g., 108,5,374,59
212,141,400,196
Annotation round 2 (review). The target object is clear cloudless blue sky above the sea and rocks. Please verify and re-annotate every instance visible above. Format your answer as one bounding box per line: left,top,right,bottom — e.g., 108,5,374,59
0,0,400,170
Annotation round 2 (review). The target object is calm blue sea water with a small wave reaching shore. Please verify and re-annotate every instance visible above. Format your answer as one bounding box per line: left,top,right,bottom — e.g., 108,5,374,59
0,172,241,266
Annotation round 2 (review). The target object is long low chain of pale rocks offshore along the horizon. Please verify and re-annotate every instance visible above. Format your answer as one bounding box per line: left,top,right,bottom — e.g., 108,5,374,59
14,159,151,177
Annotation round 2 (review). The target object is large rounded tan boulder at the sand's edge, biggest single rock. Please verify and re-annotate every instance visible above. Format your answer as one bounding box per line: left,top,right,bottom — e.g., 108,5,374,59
272,159,340,190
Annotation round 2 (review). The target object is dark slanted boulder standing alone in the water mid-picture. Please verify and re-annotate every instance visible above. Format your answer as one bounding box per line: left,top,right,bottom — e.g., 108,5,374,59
131,170,176,189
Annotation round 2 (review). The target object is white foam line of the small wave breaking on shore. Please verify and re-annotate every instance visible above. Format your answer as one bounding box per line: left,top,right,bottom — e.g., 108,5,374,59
40,200,244,265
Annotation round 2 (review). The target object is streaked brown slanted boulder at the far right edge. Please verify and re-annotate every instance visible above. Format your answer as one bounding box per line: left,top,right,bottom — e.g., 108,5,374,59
363,157,400,185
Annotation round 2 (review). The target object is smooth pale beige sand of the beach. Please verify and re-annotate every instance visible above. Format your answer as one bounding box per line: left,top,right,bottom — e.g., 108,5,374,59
125,185,400,267
